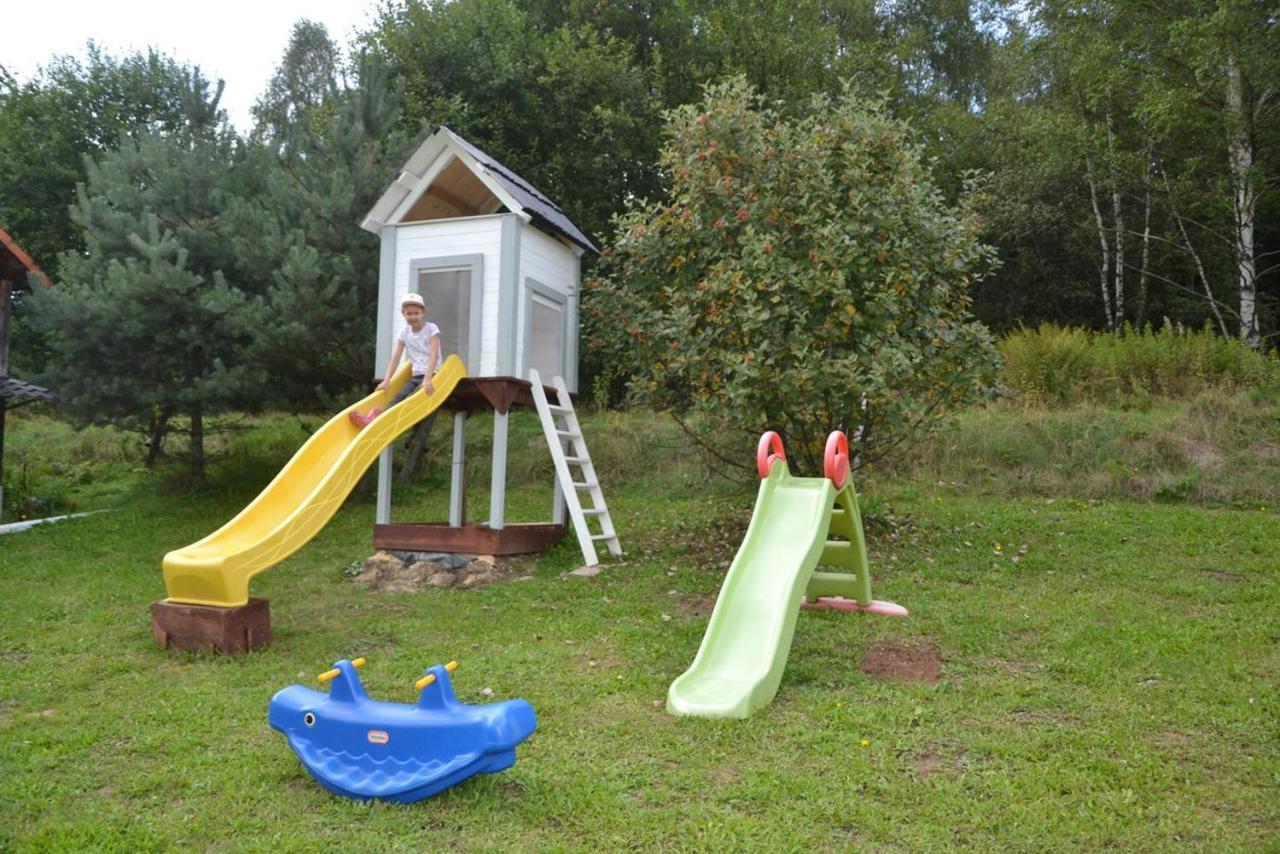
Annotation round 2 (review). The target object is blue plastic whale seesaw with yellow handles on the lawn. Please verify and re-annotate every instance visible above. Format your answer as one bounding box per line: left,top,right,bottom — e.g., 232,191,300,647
268,658,538,804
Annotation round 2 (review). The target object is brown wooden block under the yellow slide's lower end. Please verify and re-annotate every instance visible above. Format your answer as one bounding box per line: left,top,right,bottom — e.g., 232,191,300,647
151,598,271,656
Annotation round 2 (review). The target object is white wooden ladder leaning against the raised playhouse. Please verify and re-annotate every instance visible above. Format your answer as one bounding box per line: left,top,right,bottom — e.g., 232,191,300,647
529,369,622,566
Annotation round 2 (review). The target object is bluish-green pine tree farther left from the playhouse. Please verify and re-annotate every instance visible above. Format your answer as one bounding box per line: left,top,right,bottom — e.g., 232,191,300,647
31,70,269,481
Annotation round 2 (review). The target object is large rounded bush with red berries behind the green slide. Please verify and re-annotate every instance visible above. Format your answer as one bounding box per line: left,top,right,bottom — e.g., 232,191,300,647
584,78,996,469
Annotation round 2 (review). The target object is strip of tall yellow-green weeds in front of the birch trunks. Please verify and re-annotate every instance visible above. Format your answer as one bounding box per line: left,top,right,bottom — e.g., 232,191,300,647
1000,321,1280,407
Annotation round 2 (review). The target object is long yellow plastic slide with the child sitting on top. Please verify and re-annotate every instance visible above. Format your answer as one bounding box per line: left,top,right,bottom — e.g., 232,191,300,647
156,356,467,608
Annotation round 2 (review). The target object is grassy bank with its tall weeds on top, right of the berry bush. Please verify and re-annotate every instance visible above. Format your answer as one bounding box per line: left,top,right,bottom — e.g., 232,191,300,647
868,324,1280,507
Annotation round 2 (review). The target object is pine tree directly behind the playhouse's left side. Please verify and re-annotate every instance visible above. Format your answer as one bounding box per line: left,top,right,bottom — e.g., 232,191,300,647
239,52,412,408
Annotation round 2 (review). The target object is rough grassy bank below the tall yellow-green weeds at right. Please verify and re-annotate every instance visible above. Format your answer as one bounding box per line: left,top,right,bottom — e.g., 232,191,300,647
885,392,1280,507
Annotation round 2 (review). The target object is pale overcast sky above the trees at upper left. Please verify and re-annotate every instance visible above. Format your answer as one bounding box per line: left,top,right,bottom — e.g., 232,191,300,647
0,0,378,131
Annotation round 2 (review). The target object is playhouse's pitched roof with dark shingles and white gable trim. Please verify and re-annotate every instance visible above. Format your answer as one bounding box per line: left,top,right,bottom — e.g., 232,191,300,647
360,125,599,252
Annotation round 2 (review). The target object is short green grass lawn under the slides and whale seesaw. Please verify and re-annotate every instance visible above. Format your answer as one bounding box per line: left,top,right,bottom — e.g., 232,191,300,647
0,409,1280,850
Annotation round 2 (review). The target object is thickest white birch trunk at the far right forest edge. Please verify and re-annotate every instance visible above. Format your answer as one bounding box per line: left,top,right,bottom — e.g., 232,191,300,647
1226,52,1262,350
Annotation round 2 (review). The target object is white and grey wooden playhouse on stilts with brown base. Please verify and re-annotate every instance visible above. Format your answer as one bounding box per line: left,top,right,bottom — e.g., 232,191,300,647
361,127,616,554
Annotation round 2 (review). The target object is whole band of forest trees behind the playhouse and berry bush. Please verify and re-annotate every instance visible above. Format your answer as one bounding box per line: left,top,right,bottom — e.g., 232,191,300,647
0,0,1280,481
